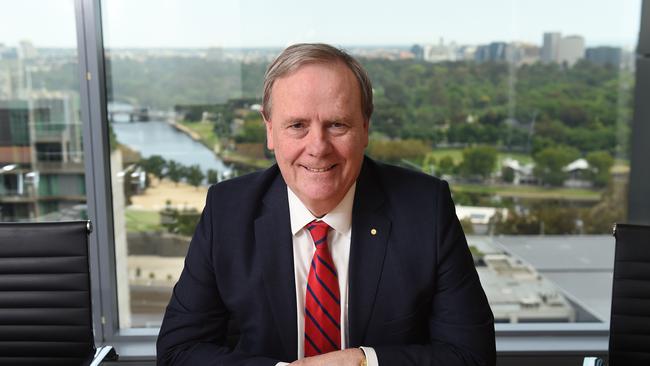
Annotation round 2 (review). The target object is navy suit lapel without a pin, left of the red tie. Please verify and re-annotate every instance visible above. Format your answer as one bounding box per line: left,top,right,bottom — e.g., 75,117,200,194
255,174,298,359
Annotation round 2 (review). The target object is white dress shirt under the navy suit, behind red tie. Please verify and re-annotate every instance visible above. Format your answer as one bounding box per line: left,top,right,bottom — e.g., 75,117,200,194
276,183,379,366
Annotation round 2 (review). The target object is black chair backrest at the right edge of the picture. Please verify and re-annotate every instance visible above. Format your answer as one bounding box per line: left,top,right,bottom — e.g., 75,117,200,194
609,224,650,366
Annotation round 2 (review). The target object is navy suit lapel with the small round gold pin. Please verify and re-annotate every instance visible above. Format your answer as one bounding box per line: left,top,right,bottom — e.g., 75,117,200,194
348,159,391,347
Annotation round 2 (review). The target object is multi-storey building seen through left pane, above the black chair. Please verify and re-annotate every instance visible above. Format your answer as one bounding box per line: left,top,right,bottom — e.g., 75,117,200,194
0,92,86,221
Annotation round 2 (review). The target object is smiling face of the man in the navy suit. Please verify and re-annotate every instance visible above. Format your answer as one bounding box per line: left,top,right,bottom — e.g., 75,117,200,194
265,62,368,216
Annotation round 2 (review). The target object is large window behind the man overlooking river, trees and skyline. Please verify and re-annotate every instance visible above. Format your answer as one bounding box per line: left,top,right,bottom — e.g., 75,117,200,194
0,0,650,356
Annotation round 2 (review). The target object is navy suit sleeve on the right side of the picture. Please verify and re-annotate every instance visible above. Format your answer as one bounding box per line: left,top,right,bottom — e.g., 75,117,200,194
375,182,496,366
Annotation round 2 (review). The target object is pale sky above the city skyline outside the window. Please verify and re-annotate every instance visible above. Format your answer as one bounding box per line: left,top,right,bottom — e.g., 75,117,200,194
0,0,641,49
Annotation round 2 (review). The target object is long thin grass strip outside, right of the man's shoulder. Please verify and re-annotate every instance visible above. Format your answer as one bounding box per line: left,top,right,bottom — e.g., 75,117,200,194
451,184,602,201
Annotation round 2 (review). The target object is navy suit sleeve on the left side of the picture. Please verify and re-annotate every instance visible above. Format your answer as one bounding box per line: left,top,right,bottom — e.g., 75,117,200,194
156,187,278,366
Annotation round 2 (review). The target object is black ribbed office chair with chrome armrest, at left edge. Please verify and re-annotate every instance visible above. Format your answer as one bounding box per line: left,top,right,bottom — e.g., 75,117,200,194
0,221,117,366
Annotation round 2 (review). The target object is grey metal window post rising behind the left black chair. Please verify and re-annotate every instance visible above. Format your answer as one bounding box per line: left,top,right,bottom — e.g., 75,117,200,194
75,0,117,344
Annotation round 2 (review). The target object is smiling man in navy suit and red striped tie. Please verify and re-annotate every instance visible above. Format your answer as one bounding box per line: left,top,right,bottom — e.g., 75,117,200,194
157,44,496,366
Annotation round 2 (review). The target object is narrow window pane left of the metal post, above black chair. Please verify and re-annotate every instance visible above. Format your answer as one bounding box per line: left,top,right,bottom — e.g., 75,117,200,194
0,0,87,221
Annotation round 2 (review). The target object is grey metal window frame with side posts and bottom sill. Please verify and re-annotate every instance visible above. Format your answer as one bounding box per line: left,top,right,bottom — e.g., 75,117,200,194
75,0,650,360
